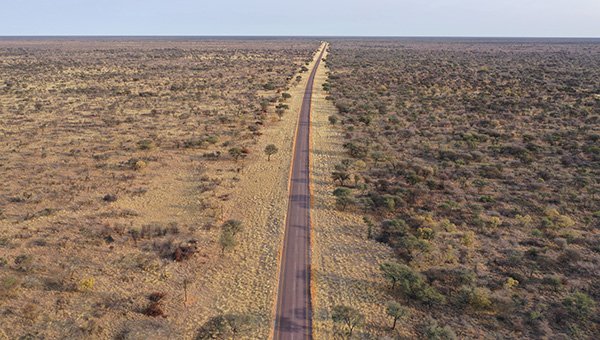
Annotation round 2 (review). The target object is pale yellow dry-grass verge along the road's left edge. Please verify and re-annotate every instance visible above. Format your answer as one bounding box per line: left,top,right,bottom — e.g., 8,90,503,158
193,42,328,339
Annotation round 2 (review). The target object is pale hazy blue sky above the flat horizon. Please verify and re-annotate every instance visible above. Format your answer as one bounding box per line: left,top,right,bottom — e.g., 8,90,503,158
0,0,600,37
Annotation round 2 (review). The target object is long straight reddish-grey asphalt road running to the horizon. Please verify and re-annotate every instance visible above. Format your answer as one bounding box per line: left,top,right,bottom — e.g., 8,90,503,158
274,45,325,340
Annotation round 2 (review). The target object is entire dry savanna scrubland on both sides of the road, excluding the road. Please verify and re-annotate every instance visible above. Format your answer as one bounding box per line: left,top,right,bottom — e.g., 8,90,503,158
0,38,600,339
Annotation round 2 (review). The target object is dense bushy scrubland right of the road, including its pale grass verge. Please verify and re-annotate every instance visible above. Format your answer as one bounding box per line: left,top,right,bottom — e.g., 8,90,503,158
313,39,600,339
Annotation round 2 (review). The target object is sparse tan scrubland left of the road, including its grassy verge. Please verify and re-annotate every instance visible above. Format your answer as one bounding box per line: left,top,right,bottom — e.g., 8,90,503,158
0,38,320,339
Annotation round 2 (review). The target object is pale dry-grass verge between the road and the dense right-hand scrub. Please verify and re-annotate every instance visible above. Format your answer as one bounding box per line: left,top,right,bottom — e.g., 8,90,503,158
311,49,400,340
